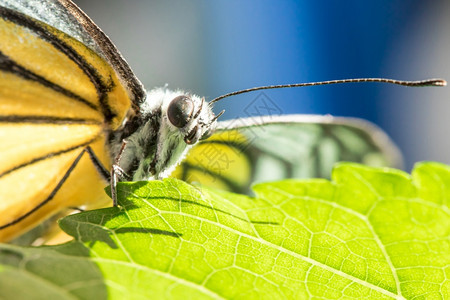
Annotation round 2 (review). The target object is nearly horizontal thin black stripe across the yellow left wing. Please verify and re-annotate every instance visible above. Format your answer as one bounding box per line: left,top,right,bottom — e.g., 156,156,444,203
0,115,102,125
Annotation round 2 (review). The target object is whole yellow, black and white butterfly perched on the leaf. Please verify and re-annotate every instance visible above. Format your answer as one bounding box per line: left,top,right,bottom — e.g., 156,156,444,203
0,0,444,241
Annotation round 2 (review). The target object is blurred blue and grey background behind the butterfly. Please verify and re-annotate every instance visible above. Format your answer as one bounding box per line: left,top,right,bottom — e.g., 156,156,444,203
75,0,450,171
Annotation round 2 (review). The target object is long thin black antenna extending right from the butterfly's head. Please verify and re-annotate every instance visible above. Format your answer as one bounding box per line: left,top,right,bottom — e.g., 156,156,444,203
209,78,447,105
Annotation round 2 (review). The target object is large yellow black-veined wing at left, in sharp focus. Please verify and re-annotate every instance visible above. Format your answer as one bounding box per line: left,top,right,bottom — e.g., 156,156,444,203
0,1,140,241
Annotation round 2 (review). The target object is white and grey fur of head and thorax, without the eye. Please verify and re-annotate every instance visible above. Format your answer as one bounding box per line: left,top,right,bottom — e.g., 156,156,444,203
115,88,216,181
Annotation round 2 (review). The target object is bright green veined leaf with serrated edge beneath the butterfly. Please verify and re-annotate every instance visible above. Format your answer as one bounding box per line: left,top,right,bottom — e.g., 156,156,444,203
0,163,450,299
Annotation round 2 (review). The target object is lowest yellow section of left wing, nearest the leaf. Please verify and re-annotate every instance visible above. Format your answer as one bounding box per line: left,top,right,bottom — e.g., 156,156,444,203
0,140,111,241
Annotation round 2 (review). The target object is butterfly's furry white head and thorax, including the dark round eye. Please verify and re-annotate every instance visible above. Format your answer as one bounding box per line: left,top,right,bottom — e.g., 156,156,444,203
110,88,216,181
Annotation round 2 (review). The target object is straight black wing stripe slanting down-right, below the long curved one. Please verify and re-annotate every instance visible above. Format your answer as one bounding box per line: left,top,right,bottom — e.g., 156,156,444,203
0,51,98,111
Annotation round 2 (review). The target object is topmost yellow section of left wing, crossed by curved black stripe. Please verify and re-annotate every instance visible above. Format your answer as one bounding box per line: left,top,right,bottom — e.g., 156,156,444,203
0,10,131,129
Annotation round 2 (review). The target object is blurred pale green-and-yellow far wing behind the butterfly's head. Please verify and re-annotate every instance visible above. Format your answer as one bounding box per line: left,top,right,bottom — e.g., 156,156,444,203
173,115,402,193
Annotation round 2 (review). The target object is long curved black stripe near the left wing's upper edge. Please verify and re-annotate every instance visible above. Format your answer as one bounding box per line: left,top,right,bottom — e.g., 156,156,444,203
0,7,116,123
